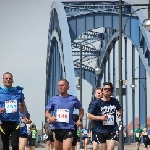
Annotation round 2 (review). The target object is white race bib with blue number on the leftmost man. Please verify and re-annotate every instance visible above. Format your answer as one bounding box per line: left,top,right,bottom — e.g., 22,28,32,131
5,100,17,113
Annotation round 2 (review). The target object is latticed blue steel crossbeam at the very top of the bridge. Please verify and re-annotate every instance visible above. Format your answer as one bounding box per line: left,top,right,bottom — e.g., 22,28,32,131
63,1,131,17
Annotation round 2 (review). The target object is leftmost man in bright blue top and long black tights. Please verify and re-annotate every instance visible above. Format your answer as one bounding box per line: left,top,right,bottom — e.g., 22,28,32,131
0,72,27,150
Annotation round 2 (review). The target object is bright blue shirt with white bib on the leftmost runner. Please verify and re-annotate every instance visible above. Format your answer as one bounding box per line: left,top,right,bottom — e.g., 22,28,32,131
0,86,24,123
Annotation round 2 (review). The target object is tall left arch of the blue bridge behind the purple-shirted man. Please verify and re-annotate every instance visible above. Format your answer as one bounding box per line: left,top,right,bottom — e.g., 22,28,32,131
47,2,76,97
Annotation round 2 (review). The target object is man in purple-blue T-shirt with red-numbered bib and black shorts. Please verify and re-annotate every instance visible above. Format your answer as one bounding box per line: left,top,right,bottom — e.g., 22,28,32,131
46,79,84,150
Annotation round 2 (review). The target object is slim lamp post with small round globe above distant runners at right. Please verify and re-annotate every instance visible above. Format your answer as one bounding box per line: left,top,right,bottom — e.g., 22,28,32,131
130,78,147,129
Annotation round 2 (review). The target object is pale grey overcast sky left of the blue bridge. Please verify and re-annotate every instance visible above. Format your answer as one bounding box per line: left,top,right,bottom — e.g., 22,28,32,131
0,0,148,128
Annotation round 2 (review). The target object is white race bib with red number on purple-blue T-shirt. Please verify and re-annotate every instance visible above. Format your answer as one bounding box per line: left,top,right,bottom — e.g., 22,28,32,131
56,109,69,123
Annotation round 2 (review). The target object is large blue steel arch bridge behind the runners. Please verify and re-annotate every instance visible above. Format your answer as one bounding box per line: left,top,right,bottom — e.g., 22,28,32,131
45,1,150,141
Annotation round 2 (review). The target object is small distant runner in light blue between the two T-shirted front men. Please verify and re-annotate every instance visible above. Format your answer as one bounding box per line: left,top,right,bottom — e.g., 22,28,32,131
81,125,89,150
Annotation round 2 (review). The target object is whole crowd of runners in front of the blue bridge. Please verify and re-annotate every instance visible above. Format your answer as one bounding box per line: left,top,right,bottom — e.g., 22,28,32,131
0,72,150,150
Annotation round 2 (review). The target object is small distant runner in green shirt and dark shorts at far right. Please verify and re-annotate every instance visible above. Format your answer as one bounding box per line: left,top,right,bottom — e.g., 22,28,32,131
134,124,142,150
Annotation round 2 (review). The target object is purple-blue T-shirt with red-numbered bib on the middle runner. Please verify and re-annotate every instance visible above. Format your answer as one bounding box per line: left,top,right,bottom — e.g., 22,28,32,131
46,95,82,129
